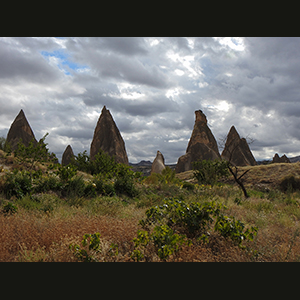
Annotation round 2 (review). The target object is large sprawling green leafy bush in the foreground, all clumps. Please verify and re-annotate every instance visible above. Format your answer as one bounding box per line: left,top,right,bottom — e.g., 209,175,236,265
131,198,257,261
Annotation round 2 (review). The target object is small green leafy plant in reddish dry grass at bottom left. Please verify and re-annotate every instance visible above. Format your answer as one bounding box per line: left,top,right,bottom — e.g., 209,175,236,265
69,232,101,262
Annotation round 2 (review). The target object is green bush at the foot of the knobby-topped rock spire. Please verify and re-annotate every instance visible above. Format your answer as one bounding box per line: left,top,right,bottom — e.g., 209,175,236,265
193,159,229,185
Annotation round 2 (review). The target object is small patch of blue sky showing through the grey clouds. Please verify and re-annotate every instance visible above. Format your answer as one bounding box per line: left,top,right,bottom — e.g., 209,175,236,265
40,50,90,75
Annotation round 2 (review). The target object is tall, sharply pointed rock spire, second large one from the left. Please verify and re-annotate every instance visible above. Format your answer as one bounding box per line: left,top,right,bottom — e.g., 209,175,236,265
90,106,128,164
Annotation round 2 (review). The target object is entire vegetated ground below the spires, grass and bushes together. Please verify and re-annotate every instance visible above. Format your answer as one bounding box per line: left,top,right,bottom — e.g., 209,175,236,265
0,142,300,262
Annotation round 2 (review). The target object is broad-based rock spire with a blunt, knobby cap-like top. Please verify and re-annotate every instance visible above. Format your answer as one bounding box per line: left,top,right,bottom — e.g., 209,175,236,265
175,110,220,173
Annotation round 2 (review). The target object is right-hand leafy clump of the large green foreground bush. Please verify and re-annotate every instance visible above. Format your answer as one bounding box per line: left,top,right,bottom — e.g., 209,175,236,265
214,215,257,247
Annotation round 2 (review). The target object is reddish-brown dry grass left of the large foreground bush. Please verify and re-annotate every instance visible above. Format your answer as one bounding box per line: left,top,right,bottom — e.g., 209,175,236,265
0,210,137,261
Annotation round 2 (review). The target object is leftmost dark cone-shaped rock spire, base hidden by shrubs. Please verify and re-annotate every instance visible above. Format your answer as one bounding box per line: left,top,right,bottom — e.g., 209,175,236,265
6,109,37,151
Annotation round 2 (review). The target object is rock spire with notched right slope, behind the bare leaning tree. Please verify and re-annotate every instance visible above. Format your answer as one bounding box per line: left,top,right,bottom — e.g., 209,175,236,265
221,126,257,166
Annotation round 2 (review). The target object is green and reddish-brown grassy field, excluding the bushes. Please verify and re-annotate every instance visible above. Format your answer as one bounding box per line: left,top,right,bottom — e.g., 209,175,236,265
0,149,300,262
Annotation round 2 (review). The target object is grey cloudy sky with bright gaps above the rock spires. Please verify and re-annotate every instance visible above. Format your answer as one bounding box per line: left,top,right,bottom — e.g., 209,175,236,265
0,37,300,164
